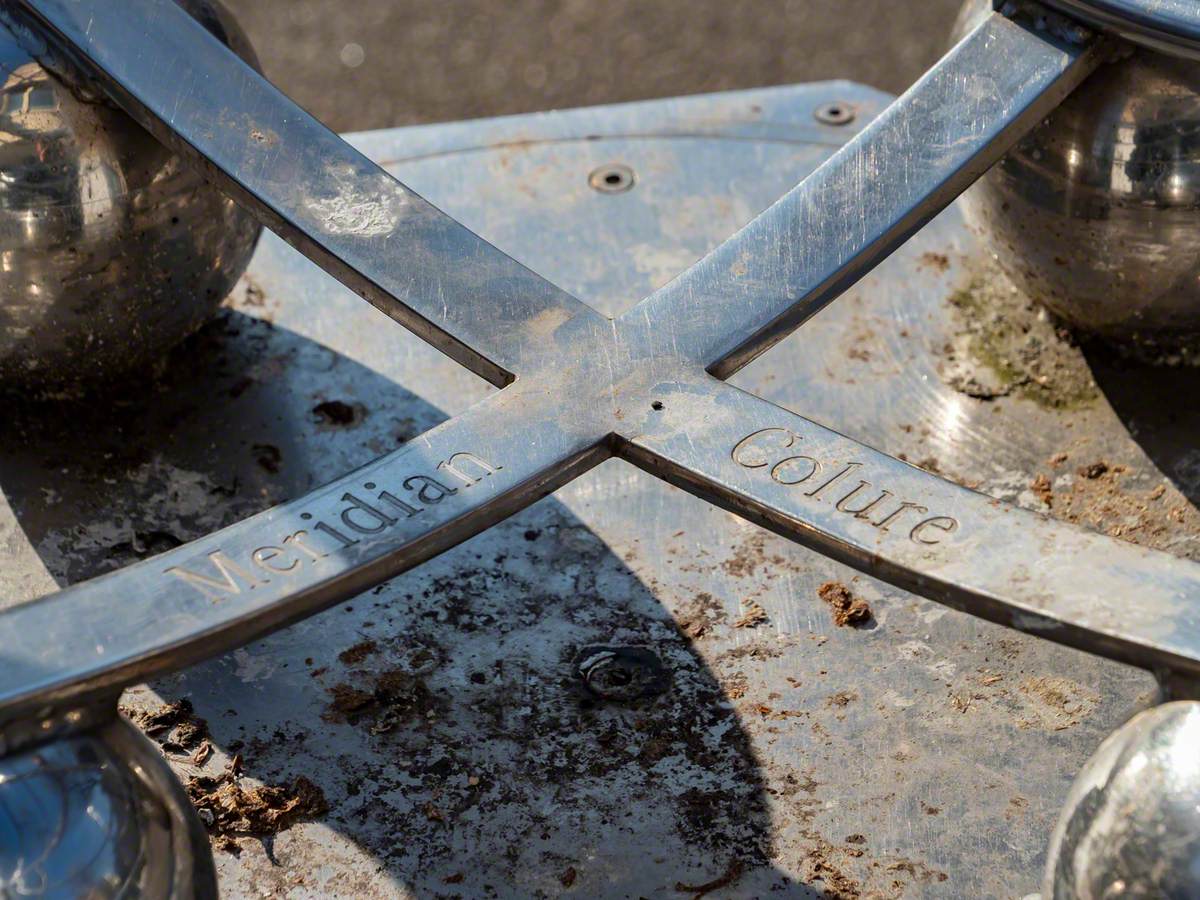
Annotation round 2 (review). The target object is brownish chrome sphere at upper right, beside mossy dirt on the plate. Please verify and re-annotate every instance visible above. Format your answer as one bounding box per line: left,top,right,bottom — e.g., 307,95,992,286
955,0,1200,346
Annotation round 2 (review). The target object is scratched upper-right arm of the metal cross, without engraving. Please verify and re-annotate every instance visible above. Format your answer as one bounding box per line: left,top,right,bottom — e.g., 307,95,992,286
624,13,1100,378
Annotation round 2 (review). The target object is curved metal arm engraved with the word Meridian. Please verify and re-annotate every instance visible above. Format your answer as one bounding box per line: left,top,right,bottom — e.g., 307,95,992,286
0,386,610,722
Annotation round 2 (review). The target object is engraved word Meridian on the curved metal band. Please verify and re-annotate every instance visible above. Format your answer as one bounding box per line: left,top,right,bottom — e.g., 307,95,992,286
163,450,504,600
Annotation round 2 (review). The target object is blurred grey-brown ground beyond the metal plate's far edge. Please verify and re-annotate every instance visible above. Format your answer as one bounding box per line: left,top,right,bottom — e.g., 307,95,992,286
226,0,960,131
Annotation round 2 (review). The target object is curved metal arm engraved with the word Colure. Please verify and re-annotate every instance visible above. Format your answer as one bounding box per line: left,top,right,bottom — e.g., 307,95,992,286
619,379,1200,673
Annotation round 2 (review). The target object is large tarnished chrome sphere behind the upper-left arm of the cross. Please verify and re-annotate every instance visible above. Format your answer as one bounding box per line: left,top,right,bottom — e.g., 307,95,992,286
0,0,259,395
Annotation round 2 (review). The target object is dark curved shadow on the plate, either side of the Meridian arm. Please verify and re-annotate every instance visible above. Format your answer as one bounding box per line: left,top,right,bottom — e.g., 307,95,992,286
0,314,823,898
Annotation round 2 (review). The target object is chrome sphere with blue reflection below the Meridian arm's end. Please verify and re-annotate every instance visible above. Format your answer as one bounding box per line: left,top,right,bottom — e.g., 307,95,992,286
0,719,217,900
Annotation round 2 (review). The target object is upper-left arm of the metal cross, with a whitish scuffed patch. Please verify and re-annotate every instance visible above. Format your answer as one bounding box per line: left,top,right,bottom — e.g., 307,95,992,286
4,0,596,385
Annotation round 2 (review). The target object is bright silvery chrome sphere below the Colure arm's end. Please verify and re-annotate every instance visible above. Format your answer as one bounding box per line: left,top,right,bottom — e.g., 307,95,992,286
1042,701,1200,900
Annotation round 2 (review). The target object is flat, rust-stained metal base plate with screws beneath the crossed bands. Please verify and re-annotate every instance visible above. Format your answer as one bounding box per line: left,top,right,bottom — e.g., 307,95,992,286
0,83,1171,898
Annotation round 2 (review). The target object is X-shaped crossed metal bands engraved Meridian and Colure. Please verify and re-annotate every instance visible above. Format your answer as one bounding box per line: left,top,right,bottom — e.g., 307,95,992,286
16,0,1200,734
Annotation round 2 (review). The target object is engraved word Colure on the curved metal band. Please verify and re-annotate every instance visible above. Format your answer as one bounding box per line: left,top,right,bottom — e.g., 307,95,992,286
730,428,959,546
